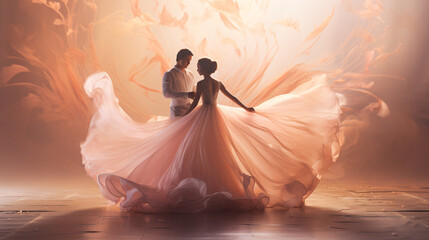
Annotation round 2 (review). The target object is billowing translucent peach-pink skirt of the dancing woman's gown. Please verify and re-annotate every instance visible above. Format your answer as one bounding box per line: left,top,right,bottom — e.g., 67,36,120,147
81,72,340,212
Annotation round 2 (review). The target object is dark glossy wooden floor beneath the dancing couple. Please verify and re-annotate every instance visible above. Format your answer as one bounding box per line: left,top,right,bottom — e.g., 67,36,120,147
0,180,429,240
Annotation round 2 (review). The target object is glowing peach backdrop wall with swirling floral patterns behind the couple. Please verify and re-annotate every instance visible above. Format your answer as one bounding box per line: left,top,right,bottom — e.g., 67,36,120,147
0,0,429,183
